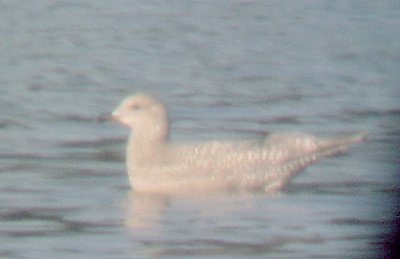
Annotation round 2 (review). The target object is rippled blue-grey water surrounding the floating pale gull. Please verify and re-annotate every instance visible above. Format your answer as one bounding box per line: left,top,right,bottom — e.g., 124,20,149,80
0,0,400,258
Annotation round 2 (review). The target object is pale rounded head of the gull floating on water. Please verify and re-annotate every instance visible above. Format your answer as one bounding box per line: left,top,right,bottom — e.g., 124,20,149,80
110,93,168,140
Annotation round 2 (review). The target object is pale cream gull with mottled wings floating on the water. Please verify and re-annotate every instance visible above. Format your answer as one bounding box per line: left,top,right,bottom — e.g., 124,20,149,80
101,93,366,195
